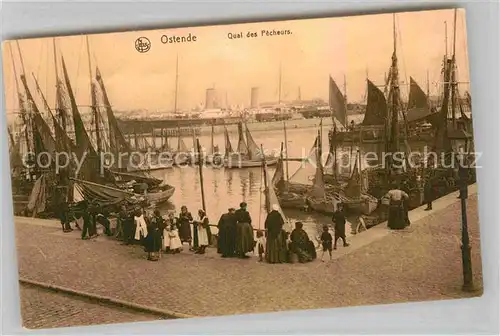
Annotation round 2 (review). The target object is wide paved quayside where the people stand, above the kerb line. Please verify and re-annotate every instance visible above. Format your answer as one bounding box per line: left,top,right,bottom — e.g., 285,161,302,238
16,195,482,316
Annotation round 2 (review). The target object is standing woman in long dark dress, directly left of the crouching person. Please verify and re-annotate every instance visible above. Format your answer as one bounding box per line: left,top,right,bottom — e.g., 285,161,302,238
265,204,287,264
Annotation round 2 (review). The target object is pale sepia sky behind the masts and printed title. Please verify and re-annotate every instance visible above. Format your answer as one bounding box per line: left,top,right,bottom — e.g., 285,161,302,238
2,9,469,113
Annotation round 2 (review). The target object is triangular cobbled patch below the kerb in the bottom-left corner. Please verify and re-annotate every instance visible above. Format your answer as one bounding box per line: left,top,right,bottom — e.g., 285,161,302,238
20,285,159,329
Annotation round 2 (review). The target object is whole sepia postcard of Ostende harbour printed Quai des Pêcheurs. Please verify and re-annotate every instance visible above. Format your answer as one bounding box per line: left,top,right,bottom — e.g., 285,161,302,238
2,9,482,328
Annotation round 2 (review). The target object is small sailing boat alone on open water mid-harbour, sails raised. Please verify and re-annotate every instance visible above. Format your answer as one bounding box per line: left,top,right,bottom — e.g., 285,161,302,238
224,122,278,168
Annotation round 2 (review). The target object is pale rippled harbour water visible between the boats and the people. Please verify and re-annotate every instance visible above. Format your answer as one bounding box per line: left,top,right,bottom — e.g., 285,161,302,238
146,127,428,238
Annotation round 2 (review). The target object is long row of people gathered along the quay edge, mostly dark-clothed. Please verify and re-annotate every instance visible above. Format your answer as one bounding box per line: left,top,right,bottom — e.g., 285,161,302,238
60,197,354,264
